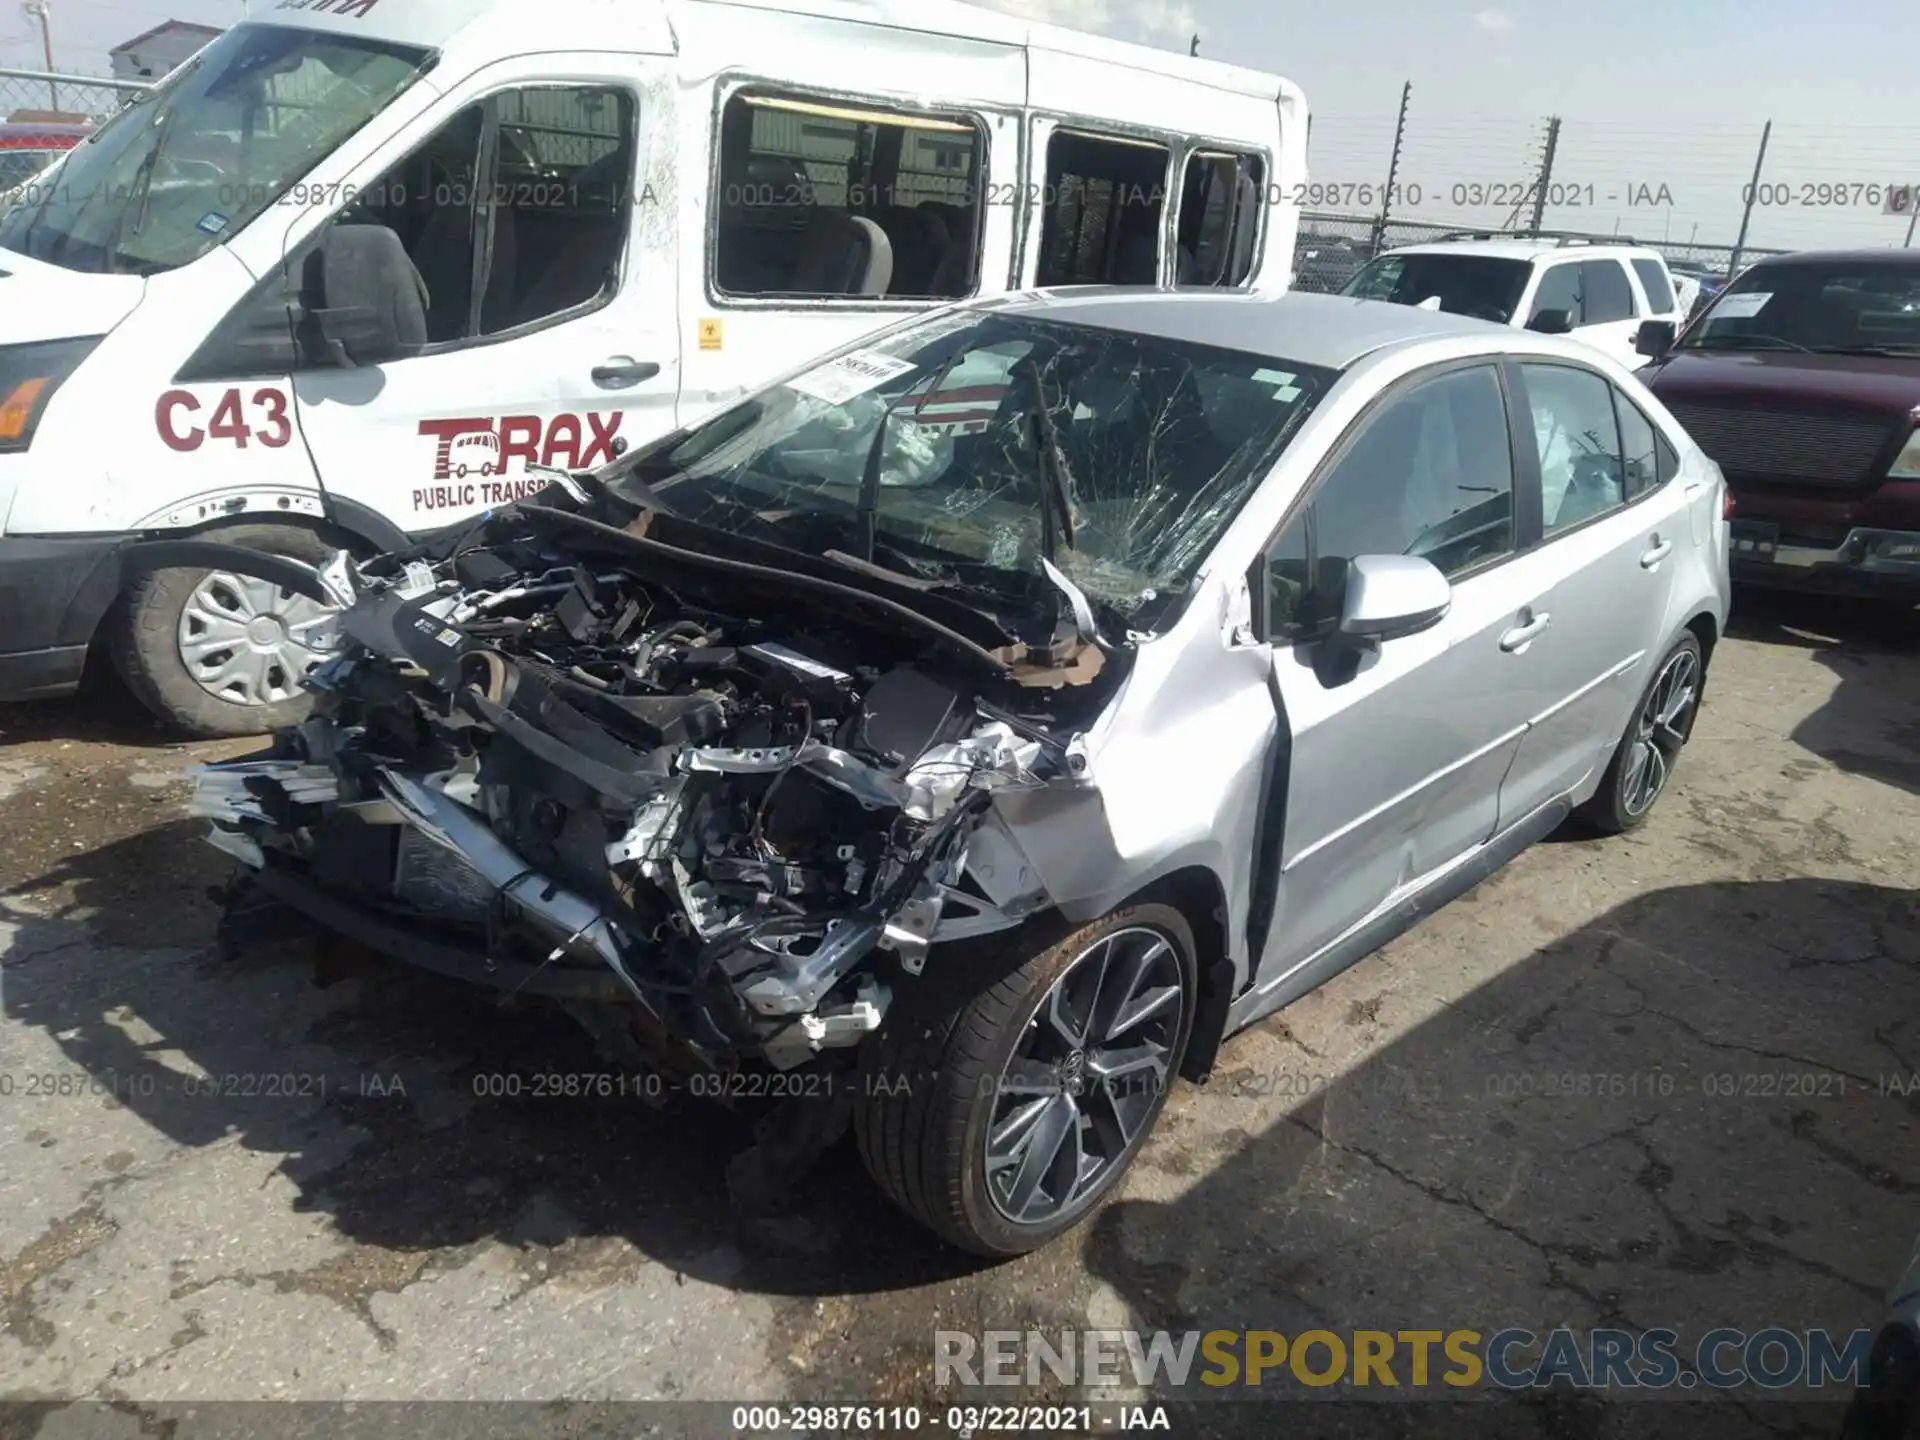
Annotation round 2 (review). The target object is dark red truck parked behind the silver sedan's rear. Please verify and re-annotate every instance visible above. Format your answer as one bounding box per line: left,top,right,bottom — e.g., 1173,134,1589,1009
1640,250,1920,605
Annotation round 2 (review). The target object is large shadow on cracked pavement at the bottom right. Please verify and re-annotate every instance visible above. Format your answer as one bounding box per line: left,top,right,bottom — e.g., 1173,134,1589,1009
1085,879,1920,1438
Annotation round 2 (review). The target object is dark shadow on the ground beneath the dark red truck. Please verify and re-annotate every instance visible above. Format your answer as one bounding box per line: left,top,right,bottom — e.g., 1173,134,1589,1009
1728,589,1920,795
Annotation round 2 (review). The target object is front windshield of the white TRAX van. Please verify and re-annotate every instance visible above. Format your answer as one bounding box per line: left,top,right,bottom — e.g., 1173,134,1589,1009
0,25,430,275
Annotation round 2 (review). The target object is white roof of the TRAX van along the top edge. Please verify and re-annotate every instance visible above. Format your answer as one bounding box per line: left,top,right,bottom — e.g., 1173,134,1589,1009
252,0,1300,100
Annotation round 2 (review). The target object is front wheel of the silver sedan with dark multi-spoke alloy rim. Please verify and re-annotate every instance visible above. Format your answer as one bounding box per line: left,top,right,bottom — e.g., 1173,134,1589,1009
854,904,1198,1258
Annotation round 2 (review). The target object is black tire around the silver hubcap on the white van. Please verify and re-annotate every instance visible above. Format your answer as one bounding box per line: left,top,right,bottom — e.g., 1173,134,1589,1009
106,524,340,739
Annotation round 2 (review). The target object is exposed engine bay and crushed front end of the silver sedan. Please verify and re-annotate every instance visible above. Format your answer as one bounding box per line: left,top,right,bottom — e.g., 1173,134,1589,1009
183,476,1127,1105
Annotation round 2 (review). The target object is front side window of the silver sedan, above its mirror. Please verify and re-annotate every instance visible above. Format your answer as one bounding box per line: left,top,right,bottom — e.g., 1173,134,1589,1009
1271,367,1513,628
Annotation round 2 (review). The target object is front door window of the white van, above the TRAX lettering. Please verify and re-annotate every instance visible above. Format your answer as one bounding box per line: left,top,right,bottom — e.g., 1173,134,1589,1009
340,86,636,346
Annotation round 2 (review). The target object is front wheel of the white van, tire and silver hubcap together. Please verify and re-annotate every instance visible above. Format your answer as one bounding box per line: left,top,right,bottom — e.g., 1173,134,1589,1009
108,524,338,739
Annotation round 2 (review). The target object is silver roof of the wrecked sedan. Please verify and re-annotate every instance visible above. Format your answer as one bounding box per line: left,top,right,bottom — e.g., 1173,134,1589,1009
981,286,1515,371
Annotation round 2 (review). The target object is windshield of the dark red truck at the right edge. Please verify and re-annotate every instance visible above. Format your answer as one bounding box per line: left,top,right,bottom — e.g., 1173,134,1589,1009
1680,261,1920,355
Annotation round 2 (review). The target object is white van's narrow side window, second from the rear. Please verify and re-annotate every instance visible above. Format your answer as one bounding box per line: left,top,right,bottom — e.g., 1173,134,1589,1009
1035,131,1171,286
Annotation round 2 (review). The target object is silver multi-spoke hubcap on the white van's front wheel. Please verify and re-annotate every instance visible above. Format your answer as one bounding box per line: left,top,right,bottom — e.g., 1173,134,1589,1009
180,570,340,707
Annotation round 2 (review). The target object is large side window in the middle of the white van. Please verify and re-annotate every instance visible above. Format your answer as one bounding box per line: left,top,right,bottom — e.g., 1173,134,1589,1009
712,92,987,300
